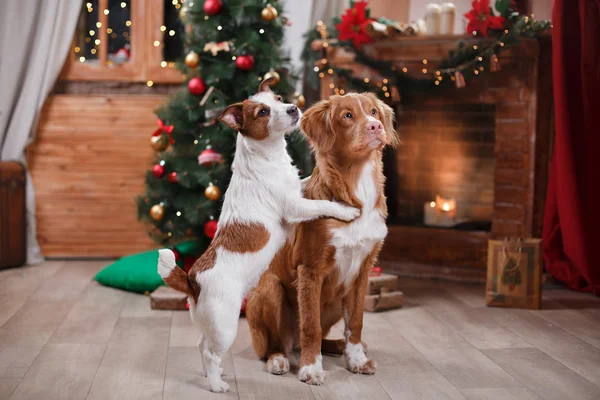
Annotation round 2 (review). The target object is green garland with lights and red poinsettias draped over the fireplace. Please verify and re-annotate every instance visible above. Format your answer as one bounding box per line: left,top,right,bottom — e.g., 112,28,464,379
302,0,552,103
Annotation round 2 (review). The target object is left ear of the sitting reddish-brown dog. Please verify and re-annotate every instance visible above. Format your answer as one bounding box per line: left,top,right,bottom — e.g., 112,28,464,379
300,100,335,152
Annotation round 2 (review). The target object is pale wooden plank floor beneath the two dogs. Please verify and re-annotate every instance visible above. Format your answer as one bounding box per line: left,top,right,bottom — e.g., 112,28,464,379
0,261,600,400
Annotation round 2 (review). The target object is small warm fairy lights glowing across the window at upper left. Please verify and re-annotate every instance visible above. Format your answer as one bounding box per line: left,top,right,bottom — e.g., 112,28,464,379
73,0,182,69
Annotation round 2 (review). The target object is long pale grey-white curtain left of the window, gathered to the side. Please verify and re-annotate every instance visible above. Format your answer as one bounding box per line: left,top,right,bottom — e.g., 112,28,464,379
0,0,82,264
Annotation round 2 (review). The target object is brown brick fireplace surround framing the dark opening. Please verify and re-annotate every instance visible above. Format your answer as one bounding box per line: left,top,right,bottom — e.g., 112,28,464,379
321,36,553,280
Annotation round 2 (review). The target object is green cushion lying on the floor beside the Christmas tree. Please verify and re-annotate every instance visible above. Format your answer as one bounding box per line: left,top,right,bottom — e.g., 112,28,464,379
94,250,165,293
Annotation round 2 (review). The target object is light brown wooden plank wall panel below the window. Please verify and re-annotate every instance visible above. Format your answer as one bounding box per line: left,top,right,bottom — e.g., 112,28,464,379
28,95,164,257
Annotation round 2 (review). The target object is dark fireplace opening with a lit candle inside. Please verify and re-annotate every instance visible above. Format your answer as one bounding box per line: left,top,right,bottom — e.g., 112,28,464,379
388,104,496,231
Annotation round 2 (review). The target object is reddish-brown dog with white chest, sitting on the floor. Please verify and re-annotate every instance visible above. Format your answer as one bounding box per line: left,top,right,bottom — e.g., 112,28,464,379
246,93,398,385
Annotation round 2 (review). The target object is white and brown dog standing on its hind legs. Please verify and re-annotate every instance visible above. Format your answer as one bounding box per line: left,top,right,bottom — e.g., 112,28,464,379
158,80,359,392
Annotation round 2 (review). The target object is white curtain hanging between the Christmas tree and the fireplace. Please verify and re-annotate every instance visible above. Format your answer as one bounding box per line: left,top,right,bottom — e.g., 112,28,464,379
284,0,350,91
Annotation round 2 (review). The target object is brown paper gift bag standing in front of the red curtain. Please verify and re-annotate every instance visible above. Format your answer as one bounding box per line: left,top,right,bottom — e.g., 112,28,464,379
485,239,542,309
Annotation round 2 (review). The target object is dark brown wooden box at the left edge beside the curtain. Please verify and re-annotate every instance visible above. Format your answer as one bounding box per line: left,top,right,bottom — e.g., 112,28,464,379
0,161,27,268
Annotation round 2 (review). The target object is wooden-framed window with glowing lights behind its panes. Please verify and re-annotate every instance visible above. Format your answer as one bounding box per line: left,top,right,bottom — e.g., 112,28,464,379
63,0,184,83
